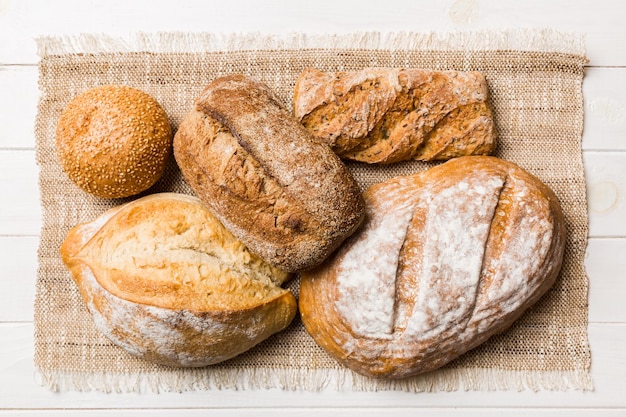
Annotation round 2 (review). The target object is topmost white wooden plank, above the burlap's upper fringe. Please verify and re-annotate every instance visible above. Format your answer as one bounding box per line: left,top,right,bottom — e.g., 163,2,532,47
0,0,626,66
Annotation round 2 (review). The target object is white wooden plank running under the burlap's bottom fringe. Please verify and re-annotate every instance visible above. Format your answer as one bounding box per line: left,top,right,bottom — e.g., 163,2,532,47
0,323,626,410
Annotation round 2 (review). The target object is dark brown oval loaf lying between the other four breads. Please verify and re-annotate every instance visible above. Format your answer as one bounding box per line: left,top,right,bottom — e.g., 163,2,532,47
174,75,364,272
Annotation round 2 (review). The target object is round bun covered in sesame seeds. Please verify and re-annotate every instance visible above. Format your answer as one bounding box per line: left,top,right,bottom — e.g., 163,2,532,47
56,85,172,198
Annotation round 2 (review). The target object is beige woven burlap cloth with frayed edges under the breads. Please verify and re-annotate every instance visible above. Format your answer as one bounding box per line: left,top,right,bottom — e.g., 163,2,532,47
35,31,592,391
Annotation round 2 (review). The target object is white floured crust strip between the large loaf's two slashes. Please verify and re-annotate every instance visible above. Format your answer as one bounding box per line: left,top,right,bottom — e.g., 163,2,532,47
405,173,504,341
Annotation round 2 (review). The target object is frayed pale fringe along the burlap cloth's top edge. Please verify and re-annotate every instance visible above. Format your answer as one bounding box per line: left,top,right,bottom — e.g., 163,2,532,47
37,29,585,58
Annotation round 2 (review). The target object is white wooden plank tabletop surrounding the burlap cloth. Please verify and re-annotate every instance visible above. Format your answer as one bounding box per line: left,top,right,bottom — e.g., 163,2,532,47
0,0,626,417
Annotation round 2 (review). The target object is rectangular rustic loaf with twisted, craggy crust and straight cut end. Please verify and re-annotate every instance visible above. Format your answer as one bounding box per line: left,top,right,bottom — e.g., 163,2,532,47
294,68,496,164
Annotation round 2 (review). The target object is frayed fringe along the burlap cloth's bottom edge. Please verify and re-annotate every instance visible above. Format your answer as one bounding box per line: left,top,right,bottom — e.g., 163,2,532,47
38,368,593,393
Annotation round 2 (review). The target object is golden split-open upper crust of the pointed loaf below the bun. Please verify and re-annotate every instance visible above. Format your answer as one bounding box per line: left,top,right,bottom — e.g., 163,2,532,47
64,193,289,311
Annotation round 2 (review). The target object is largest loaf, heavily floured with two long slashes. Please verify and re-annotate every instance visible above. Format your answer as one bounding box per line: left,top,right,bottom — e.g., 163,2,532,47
299,156,567,378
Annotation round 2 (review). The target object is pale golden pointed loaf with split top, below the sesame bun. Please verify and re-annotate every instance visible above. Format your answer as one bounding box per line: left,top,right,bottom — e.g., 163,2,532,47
61,193,296,367
